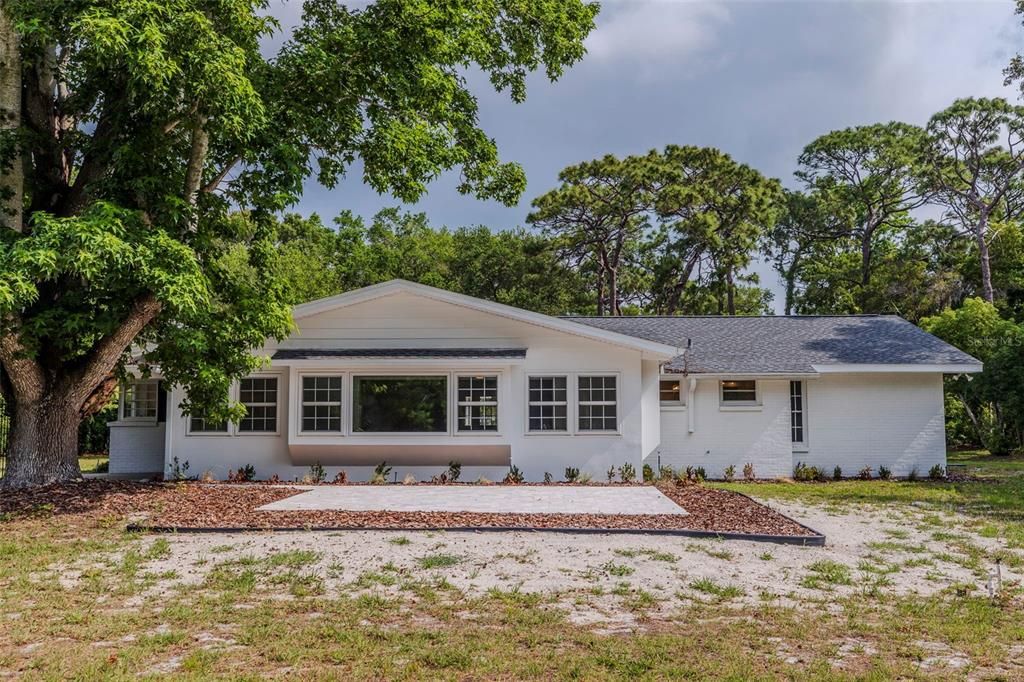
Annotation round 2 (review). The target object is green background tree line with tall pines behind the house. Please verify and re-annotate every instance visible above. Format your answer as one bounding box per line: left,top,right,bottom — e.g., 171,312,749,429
268,98,1024,453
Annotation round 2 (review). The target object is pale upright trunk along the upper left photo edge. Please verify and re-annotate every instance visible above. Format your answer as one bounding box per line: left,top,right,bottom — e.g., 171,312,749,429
0,0,25,231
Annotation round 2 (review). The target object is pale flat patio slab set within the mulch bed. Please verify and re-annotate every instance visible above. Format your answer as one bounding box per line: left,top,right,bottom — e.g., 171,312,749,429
259,485,686,516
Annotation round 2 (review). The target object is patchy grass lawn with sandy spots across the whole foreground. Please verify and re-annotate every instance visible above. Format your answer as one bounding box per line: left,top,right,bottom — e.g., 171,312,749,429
0,458,1024,680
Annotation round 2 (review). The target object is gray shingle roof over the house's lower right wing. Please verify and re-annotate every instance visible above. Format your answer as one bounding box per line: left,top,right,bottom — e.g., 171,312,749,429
565,315,980,374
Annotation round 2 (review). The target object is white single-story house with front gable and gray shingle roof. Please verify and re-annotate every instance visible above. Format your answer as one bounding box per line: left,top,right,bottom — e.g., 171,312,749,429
110,280,981,480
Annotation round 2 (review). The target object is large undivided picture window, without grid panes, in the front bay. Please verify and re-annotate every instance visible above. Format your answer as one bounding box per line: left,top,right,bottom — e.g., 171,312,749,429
352,377,449,433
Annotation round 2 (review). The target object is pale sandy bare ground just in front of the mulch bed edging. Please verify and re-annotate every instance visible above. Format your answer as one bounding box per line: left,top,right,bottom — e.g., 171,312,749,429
86,493,1024,622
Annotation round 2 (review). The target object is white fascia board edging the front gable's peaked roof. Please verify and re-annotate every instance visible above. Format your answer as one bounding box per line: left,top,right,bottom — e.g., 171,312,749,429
292,280,683,359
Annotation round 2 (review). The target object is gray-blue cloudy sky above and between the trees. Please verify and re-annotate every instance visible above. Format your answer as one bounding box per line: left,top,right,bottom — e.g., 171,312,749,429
275,0,1024,303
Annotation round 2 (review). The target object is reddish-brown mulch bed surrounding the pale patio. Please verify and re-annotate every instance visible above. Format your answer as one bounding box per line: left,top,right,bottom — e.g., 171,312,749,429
0,480,819,538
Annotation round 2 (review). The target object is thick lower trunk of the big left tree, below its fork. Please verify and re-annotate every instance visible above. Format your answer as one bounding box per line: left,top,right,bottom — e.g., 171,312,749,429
0,389,82,489
